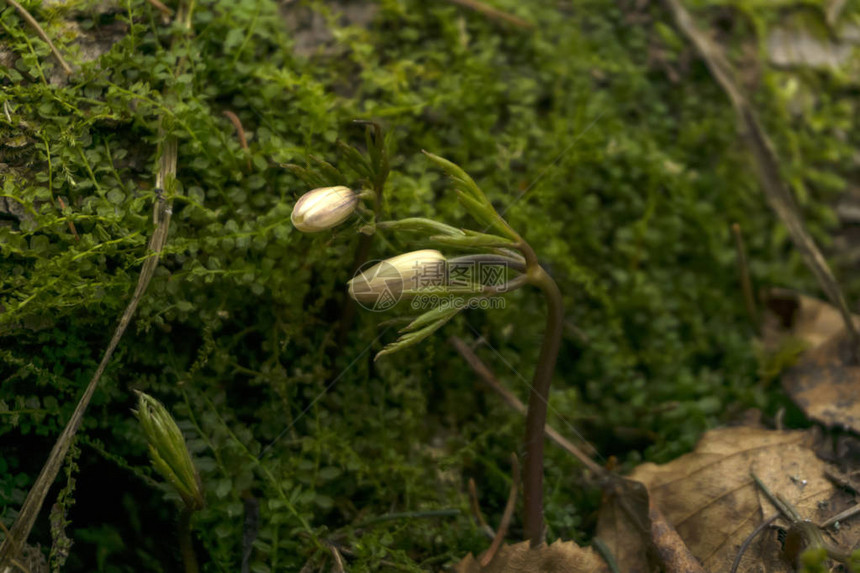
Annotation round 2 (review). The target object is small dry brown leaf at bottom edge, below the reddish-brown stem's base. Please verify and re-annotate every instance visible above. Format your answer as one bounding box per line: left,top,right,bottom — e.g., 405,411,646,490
455,541,609,573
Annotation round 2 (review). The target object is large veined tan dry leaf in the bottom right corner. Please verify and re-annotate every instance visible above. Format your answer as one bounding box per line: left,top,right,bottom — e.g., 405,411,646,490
598,428,860,573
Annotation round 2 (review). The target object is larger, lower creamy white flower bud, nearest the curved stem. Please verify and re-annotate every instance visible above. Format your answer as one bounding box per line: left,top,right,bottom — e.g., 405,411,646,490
349,249,446,310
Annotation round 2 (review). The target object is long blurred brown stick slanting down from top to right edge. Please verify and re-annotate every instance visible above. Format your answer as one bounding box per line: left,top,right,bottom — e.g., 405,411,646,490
664,0,860,360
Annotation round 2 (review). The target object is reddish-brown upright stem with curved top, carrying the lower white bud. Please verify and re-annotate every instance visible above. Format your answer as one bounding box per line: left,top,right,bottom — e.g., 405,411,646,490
520,241,564,547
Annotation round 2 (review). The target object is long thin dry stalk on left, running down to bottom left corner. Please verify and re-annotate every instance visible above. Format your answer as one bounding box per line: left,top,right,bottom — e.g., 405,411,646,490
0,136,176,567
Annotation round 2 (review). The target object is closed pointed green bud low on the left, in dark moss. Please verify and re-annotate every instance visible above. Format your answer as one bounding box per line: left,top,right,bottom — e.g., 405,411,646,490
135,392,203,510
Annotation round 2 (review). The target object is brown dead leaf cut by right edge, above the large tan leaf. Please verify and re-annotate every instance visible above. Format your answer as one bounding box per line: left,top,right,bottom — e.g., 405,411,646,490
782,330,860,432
